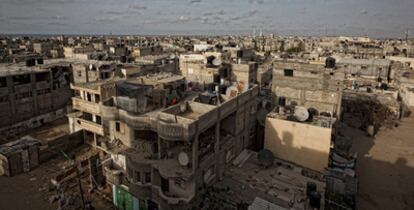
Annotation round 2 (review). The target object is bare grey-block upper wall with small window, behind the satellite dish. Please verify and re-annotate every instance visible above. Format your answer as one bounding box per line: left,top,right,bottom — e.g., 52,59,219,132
272,62,344,116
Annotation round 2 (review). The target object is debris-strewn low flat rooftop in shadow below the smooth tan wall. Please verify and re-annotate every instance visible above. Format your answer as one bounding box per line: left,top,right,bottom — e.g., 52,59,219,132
215,151,326,210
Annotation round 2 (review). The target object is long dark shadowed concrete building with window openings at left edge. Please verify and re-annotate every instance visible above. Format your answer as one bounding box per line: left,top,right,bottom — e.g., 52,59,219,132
0,59,72,133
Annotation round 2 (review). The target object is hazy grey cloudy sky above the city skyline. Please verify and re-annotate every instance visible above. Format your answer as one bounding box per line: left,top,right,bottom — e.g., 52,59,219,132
0,0,414,37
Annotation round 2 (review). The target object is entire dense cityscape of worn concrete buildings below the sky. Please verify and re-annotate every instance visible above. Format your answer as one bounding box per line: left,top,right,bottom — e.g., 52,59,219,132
0,14,414,210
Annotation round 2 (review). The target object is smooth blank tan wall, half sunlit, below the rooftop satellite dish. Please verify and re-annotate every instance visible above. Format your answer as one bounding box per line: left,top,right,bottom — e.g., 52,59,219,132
264,118,332,171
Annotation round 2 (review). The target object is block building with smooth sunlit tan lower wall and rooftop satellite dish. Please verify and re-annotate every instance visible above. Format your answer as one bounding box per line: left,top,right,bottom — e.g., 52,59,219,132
264,59,344,173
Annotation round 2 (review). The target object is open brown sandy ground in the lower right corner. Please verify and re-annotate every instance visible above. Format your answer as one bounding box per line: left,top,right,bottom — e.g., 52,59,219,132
348,111,414,210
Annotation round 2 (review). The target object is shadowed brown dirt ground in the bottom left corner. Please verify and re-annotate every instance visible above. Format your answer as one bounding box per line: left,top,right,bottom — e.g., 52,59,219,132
0,146,114,210
